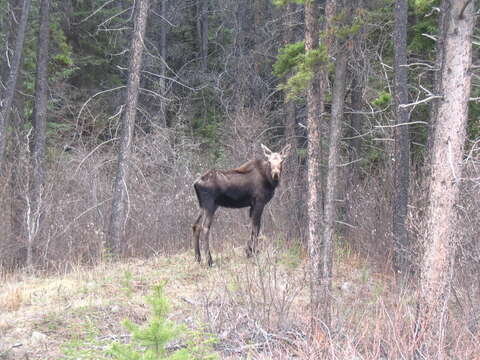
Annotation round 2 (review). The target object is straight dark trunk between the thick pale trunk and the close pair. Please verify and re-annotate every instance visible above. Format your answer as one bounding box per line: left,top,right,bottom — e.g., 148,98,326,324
392,0,410,272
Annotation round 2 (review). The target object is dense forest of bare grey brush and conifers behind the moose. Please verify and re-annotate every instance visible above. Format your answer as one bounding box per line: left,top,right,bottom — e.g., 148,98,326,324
0,0,480,353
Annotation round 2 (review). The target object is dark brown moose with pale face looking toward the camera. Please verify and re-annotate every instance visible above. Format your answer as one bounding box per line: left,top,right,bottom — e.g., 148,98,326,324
193,144,290,266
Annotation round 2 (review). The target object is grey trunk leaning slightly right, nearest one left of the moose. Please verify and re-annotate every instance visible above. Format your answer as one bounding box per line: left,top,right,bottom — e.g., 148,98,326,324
107,0,149,256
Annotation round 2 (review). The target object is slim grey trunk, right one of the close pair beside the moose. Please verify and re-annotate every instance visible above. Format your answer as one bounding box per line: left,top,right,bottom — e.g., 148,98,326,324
320,50,347,329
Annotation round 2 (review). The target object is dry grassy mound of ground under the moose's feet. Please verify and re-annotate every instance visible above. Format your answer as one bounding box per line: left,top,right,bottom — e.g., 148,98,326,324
0,245,408,360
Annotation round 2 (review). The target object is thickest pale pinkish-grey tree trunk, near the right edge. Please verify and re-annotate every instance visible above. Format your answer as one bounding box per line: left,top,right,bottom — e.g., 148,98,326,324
417,0,475,359
